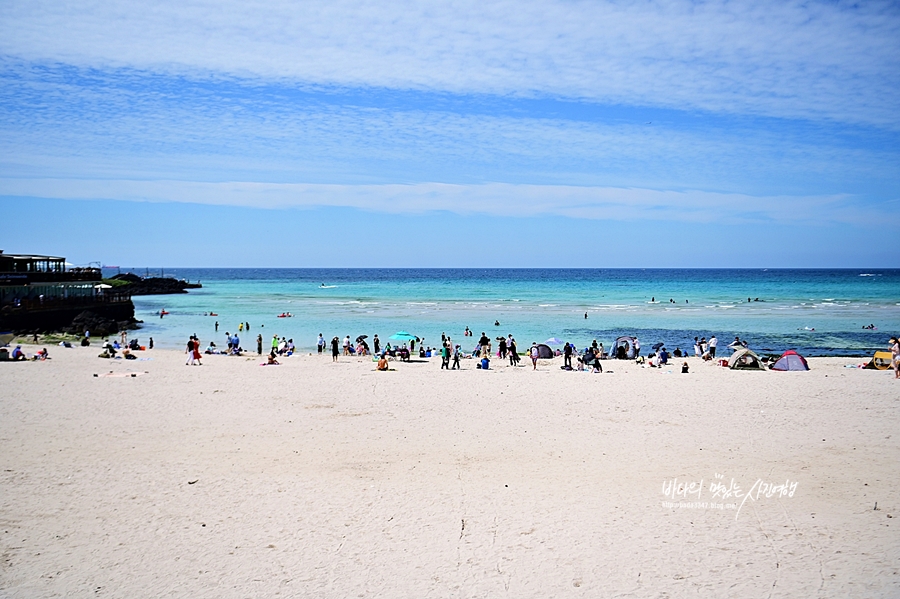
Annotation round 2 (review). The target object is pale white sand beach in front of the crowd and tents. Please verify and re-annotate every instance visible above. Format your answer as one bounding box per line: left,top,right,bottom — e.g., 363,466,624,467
0,347,900,599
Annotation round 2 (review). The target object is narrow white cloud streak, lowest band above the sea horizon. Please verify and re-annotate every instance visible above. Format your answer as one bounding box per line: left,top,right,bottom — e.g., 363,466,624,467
0,179,900,230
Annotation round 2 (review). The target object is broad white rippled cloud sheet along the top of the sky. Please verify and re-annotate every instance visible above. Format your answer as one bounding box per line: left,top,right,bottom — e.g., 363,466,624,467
0,0,900,129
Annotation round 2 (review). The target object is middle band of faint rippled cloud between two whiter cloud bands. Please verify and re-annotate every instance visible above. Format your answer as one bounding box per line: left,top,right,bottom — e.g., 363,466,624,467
0,69,900,195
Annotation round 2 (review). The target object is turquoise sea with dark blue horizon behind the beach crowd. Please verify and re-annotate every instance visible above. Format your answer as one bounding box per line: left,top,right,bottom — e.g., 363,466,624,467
104,268,900,356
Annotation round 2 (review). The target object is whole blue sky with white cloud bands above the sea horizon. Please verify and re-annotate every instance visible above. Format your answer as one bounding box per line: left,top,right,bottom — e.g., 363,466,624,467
0,0,900,267
